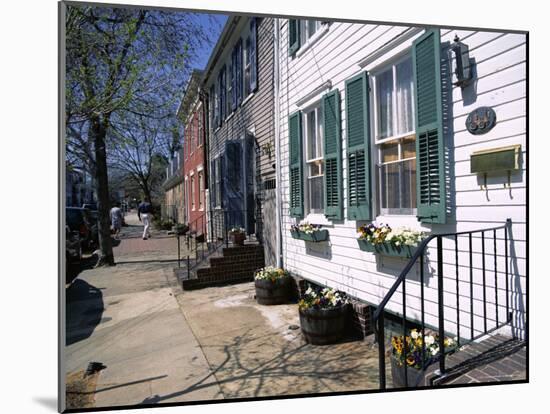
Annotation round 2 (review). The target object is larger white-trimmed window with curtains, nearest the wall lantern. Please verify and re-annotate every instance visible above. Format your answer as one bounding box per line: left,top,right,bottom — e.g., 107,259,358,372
372,54,416,215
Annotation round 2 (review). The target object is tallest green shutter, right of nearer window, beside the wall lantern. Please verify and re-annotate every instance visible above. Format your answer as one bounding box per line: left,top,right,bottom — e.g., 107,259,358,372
413,29,446,223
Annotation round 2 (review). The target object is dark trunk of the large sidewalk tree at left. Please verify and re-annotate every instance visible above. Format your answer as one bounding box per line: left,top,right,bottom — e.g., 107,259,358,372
90,117,115,266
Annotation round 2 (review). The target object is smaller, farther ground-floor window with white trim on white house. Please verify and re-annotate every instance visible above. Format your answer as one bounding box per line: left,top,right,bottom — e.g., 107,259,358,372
302,103,324,214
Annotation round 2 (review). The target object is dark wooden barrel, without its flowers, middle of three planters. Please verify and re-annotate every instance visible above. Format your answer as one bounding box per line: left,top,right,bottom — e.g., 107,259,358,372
299,305,348,345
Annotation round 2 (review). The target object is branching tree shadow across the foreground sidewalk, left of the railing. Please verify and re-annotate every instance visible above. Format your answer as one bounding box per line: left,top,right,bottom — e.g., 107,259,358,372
142,330,378,404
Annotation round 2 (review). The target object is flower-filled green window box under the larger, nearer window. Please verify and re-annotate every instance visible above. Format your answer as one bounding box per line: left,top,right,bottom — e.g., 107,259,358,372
357,223,426,258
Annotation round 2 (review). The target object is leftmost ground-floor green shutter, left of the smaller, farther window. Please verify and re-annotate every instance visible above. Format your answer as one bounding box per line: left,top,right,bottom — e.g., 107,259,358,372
288,111,304,217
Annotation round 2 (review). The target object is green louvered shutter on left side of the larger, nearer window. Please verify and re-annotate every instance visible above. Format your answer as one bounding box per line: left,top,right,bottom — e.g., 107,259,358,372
346,72,371,220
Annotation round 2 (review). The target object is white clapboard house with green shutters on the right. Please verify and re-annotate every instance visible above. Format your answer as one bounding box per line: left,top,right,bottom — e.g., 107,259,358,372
277,19,527,376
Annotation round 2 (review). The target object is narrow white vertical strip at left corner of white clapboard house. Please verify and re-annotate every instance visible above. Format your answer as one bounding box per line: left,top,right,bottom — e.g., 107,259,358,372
273,18,283,267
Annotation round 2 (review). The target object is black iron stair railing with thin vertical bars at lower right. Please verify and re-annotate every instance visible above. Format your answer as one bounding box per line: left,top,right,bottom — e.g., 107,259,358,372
373,219,512,389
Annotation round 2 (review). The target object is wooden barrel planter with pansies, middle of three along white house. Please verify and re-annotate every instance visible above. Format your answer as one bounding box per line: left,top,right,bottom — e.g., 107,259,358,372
298,286,348,345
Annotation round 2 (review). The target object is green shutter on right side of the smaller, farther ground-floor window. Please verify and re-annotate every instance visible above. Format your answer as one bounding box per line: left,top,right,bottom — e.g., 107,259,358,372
323,89,343,220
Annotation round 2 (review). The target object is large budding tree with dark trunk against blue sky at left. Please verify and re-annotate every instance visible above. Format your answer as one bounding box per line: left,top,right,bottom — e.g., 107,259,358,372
65,4,220,265
